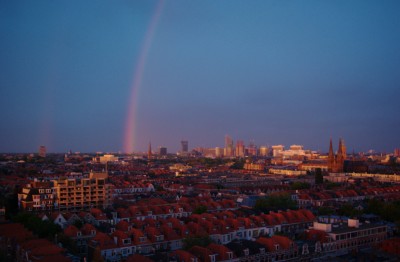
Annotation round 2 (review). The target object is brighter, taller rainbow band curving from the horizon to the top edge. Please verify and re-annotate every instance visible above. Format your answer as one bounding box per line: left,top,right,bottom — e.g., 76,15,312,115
123,0,164,153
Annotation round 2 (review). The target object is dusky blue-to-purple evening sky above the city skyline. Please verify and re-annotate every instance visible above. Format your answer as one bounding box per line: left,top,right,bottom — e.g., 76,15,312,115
0,0,400,152
